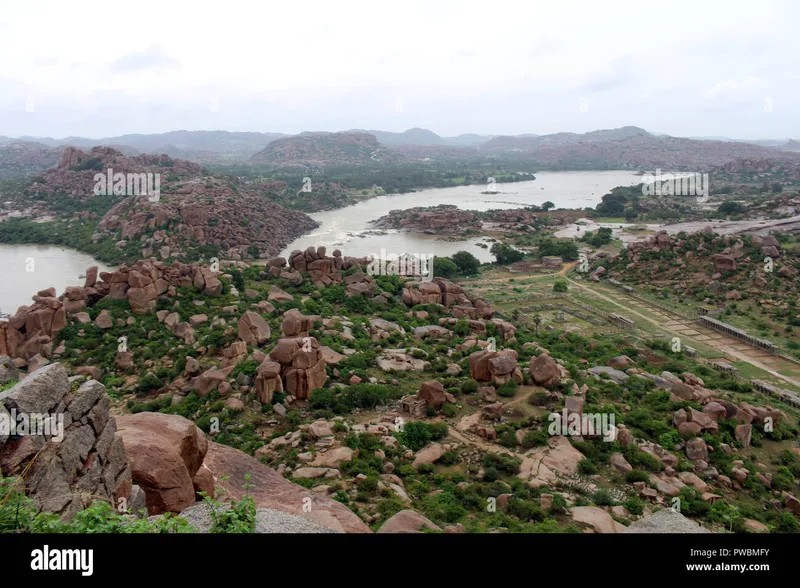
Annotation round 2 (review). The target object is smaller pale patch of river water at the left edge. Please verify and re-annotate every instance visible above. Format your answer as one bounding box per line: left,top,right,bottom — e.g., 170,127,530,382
0,245,113,314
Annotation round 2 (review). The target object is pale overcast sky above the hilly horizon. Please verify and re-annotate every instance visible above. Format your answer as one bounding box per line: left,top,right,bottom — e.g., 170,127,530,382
0,0,800,139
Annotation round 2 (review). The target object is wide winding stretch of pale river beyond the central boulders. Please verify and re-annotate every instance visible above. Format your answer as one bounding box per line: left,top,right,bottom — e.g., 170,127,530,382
281,171,641,261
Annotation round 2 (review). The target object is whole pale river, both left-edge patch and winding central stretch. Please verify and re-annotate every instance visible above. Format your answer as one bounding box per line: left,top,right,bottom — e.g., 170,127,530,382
0,171,641,314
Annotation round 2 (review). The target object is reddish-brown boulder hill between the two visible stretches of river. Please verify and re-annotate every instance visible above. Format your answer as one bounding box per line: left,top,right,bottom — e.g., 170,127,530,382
10,147,321,260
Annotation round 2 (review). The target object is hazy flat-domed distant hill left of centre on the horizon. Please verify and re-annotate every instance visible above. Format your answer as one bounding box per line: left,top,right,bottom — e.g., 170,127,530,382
250,132,402,167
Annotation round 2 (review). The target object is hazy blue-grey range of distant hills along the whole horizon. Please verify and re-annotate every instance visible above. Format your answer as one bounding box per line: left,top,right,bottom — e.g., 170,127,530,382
0,126,800,178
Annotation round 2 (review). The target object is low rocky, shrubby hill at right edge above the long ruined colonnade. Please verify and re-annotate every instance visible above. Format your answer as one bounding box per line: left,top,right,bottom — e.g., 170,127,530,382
591,226,800,358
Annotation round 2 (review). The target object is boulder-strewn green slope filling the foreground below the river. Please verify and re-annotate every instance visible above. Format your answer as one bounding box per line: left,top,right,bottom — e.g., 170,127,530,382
0,238,800,533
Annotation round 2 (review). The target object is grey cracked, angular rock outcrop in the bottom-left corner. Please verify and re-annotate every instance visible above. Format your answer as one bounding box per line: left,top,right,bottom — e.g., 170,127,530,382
0,363,133,520
